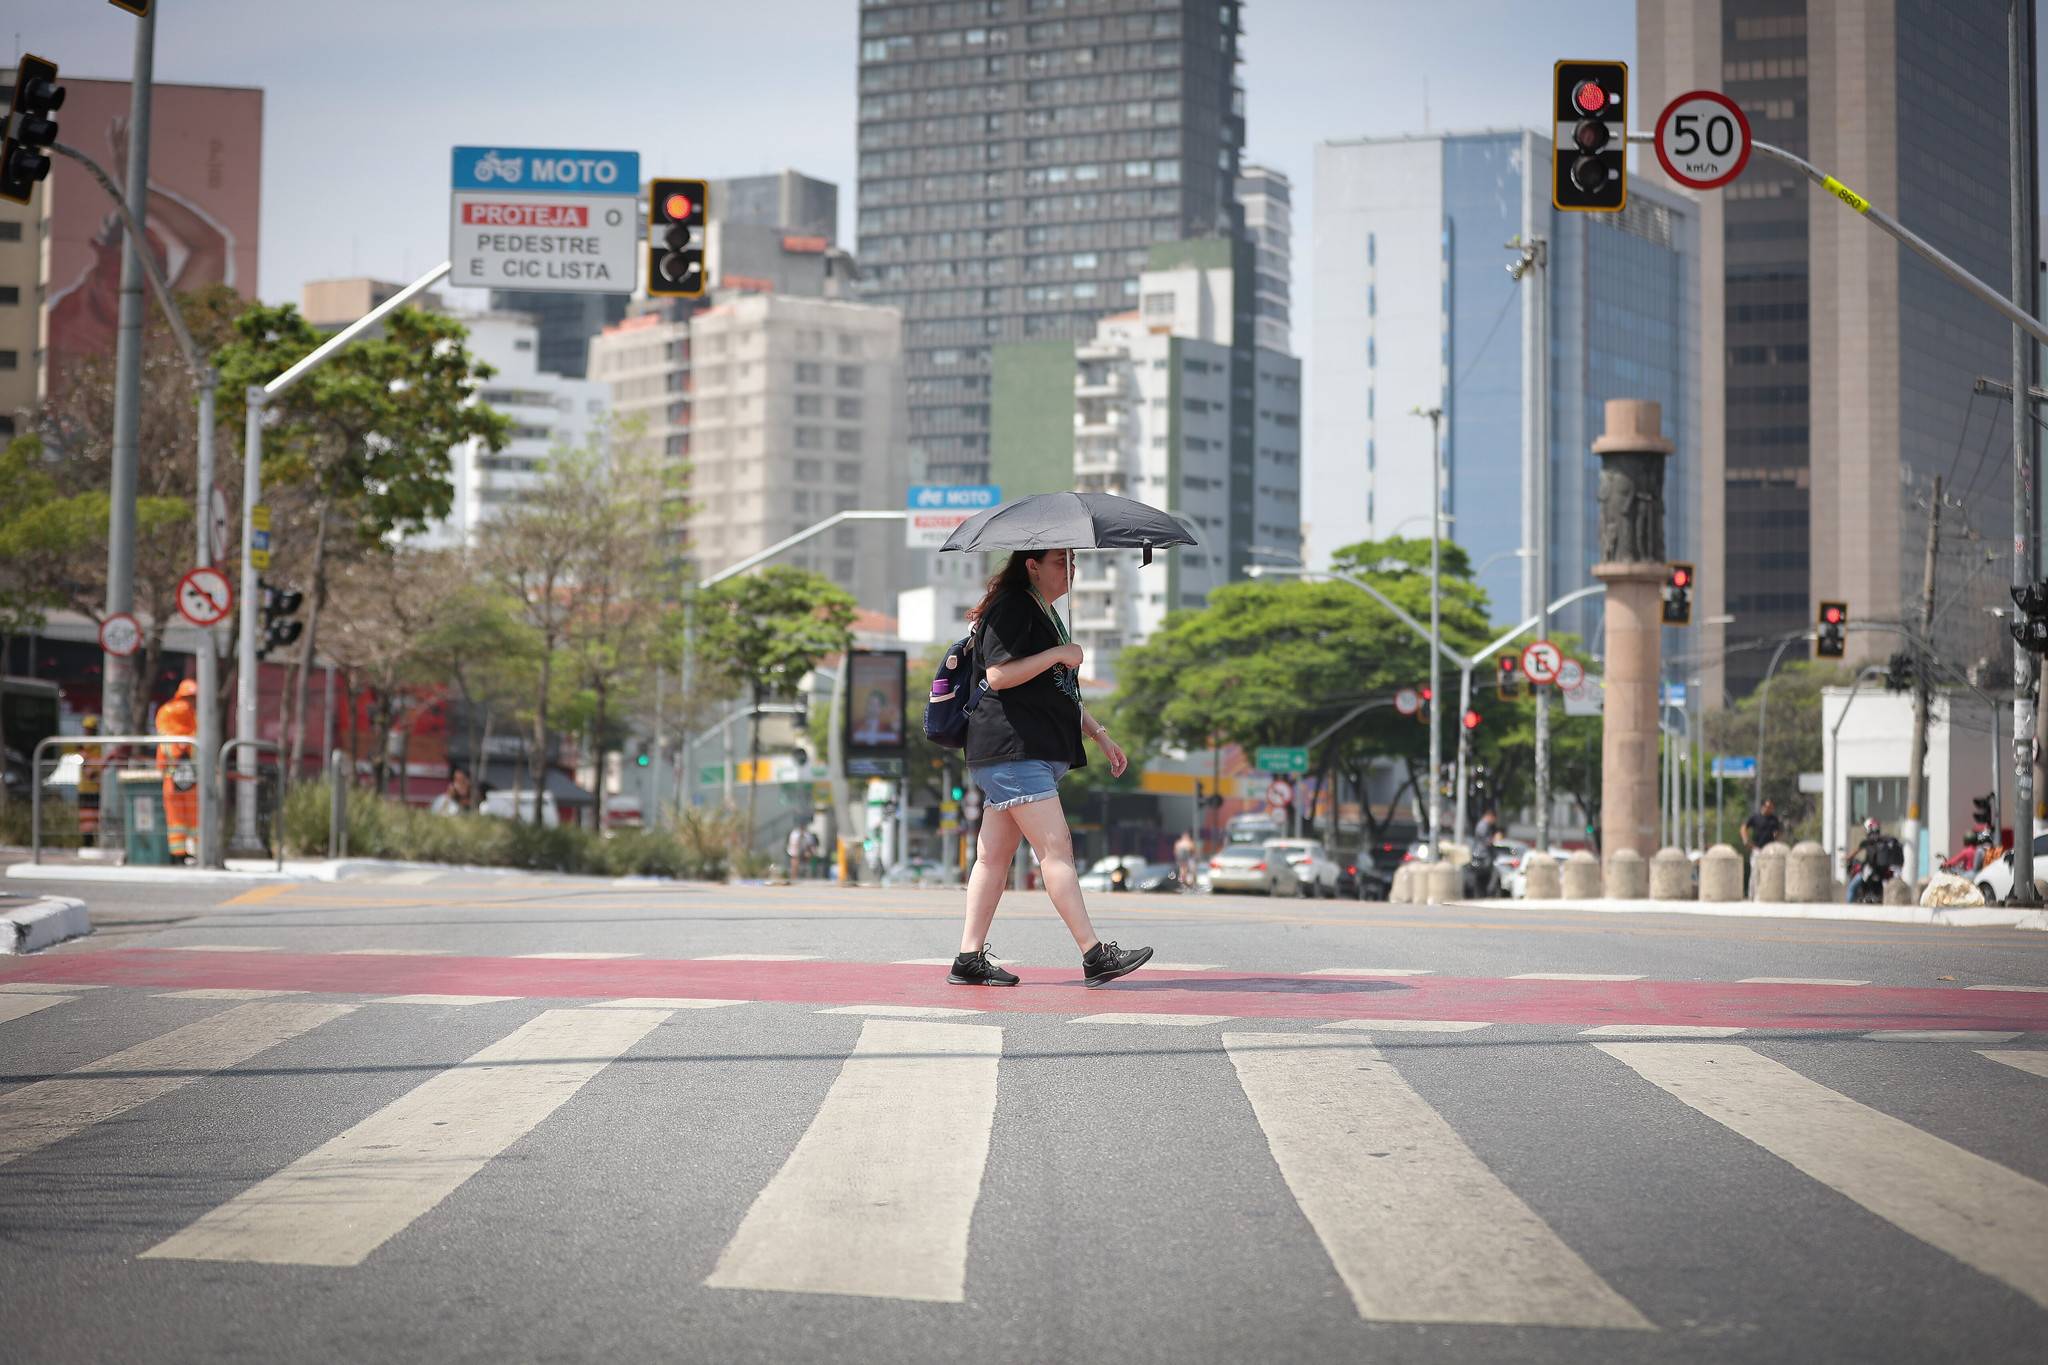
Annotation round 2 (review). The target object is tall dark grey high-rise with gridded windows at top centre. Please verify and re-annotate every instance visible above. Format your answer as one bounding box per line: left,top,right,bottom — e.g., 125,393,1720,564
858,0,1249,483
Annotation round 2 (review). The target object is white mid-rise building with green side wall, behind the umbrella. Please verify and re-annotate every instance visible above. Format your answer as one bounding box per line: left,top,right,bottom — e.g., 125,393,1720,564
978,237,1300,681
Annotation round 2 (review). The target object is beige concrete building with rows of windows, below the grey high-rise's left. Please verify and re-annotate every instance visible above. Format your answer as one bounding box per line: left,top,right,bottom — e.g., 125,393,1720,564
592,291,907,614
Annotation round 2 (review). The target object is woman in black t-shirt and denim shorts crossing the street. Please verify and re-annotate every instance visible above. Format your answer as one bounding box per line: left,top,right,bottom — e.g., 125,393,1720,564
946,551,1151,986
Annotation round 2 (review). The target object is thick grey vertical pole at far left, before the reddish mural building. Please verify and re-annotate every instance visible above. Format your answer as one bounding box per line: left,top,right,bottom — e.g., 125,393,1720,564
100,6,155,735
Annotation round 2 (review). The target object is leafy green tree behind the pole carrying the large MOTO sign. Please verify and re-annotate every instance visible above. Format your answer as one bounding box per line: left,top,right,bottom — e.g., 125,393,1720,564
217,303,510,772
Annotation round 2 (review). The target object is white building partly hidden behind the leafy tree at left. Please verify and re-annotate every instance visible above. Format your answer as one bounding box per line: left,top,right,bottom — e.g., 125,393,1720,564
422,313,610,546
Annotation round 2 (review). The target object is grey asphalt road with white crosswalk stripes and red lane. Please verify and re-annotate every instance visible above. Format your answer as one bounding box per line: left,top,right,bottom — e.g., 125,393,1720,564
0,872,2048,1365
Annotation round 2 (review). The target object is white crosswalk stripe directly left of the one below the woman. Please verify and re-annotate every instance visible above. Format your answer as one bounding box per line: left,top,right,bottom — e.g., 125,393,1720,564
143,1009,668,1265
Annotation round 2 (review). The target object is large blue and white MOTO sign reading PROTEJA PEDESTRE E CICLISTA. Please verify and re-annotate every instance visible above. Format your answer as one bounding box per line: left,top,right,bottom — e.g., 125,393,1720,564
449,147,639,295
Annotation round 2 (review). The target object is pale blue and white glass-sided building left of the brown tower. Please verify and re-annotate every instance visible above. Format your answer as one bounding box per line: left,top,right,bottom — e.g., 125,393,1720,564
1303,129,1702,636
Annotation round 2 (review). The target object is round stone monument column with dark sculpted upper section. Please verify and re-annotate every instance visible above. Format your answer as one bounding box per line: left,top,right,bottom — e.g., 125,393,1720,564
1593,399,1671,862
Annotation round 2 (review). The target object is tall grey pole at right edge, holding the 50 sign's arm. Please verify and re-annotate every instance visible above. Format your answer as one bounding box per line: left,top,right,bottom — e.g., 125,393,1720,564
2005,0,2040,905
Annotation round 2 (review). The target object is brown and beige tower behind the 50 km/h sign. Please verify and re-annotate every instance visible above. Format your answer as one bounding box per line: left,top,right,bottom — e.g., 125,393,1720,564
1632,0,2038,698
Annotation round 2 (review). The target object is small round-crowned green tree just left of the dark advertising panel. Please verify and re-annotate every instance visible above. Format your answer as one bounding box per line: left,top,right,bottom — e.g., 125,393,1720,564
696,565,854,849
